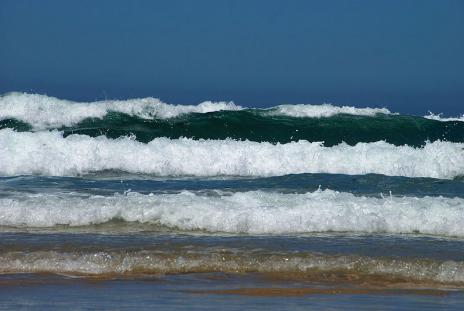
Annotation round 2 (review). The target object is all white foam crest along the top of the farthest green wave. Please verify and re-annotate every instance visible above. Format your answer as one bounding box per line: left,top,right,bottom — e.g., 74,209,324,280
0,93,390,130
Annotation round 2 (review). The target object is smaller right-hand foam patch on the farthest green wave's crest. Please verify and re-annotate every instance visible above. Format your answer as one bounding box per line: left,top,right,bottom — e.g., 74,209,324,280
268,104,391,118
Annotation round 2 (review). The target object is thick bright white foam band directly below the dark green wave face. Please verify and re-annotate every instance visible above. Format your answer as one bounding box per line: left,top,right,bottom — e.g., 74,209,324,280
0,129,464,179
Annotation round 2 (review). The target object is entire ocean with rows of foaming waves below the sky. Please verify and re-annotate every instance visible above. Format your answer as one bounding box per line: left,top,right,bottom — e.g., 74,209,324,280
0,93,464,310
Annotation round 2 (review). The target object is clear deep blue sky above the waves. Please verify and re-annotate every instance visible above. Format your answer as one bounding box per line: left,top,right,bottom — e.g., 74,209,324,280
0,0,464,114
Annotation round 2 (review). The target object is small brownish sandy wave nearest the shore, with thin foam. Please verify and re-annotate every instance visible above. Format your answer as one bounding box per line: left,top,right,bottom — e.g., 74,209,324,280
0,248,464,286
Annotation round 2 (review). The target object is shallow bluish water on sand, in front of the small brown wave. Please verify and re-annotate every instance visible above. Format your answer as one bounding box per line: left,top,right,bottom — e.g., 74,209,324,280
0,274,464,310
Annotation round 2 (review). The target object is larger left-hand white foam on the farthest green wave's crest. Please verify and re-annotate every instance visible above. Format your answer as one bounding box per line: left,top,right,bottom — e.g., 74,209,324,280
0,93,242,130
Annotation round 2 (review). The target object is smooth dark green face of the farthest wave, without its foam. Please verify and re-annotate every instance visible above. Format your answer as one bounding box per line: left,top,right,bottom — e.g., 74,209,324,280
0,110,464,146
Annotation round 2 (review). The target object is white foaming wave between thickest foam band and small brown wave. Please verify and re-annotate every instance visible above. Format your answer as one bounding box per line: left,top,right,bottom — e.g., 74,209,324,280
0,190,464,237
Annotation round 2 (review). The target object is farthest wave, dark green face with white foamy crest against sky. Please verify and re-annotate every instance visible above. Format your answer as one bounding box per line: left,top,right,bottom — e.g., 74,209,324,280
0,93,464,147
